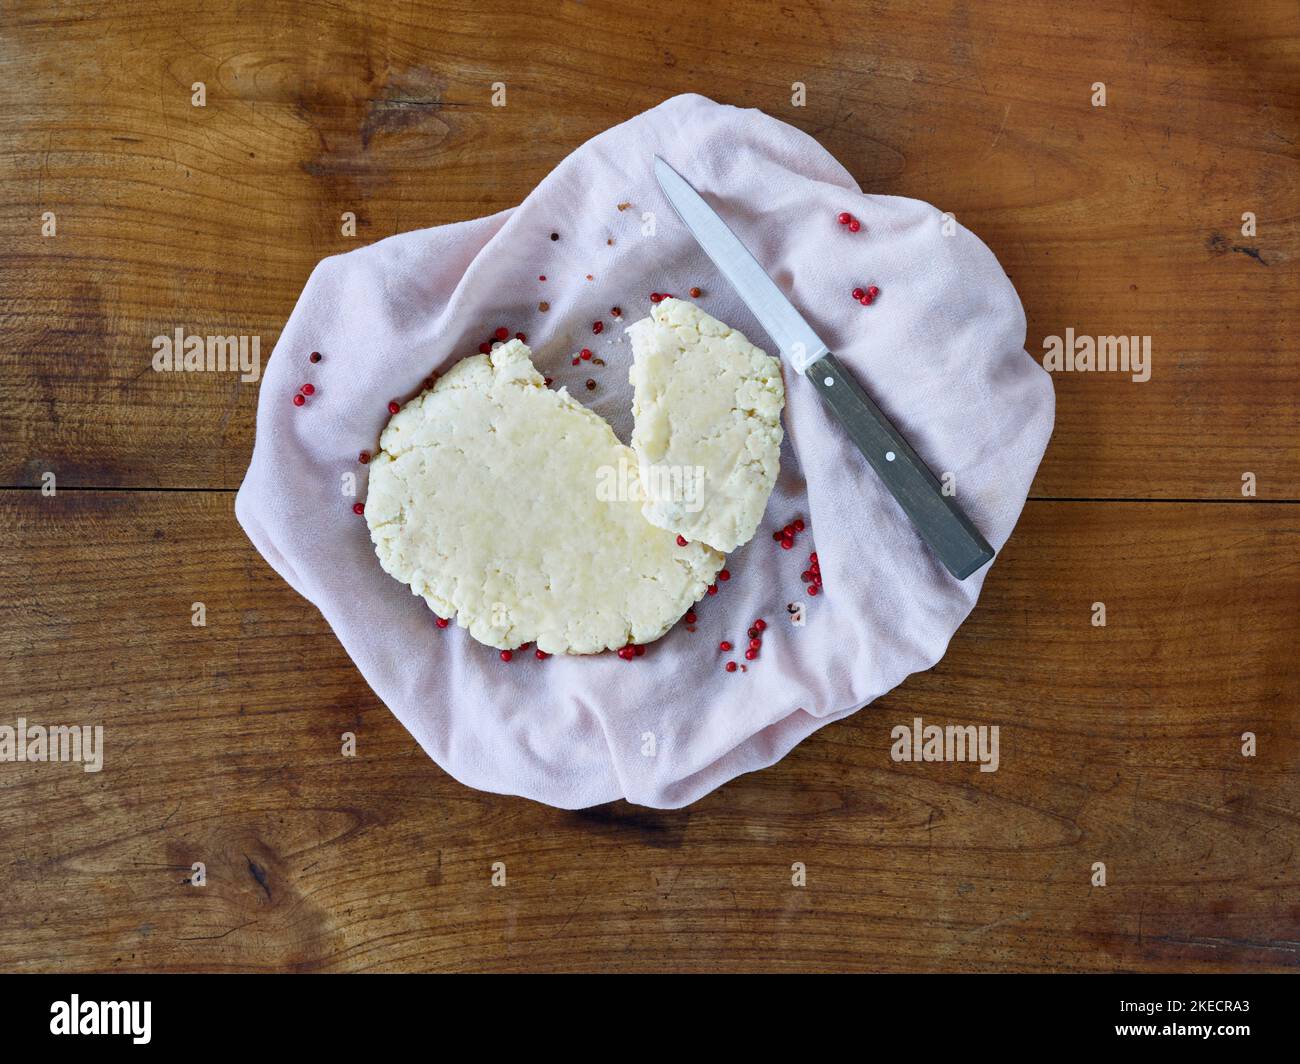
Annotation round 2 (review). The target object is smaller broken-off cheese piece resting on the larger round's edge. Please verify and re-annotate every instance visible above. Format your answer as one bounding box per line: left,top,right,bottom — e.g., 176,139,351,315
628,299,785,552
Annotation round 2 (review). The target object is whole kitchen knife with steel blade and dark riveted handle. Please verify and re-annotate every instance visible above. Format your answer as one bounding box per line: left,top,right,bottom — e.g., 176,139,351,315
654,155,993,580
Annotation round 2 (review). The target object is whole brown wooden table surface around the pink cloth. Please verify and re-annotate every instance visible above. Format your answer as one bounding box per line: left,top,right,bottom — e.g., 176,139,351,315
0,0,1300,972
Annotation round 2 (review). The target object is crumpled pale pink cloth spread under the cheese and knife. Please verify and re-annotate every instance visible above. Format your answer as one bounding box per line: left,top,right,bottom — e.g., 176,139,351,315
235,95,1053,809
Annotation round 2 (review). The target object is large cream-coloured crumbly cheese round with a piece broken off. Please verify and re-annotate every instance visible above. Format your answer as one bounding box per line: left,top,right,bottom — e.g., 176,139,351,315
365,339,724,654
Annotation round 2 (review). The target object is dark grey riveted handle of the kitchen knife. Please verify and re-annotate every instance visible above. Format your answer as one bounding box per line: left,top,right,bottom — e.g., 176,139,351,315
805,355,993,580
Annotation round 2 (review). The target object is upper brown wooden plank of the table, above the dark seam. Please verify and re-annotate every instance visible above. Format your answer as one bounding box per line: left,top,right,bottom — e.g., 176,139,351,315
0,0,1300,499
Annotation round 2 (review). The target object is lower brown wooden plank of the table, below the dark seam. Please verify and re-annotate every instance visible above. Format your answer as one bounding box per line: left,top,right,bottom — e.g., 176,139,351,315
0,492,1300,972
